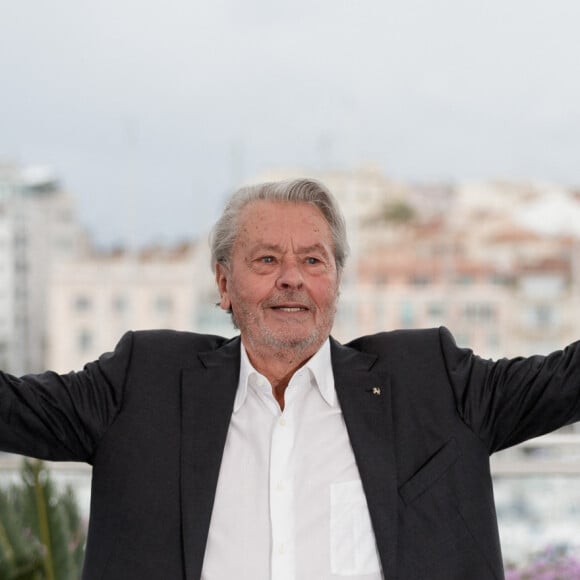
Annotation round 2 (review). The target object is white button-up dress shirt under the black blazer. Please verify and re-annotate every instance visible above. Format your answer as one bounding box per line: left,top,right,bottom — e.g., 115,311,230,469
201,340,382,580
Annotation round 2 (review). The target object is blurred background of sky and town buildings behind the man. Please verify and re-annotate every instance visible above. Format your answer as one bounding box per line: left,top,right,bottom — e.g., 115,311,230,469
0,0,580,563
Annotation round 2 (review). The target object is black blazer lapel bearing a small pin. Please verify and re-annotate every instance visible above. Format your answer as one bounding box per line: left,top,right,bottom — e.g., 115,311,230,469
331,340,397,578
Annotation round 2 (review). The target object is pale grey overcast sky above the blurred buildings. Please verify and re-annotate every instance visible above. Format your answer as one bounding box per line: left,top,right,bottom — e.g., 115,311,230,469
0,0,580,244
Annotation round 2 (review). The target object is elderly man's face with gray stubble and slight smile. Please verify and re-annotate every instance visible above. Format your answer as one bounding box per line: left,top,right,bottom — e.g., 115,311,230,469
216,201,339,359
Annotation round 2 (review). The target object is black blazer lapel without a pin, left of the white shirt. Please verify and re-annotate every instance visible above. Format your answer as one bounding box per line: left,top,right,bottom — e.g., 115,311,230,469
181,338,240,580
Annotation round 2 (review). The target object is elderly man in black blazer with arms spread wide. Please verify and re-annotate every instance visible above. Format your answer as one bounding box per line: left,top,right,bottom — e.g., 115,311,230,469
0,180,580,580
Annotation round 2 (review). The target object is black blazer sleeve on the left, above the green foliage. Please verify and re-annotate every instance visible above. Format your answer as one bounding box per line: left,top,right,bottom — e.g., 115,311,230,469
0,332,133,463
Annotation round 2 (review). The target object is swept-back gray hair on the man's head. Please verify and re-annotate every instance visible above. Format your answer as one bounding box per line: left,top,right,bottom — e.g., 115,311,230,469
210,179,349,273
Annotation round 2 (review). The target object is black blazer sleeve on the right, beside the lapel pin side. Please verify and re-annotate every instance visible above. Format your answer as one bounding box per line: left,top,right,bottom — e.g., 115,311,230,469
440,328,580,453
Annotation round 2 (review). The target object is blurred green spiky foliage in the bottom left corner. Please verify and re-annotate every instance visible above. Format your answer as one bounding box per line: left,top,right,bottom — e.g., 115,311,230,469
0,459,85,580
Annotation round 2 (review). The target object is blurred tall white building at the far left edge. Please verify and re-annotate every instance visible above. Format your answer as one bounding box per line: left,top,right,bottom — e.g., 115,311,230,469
0,165,85,374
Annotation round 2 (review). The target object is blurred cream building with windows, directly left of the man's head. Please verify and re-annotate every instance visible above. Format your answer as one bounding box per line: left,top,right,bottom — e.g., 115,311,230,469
47,243,234,372
